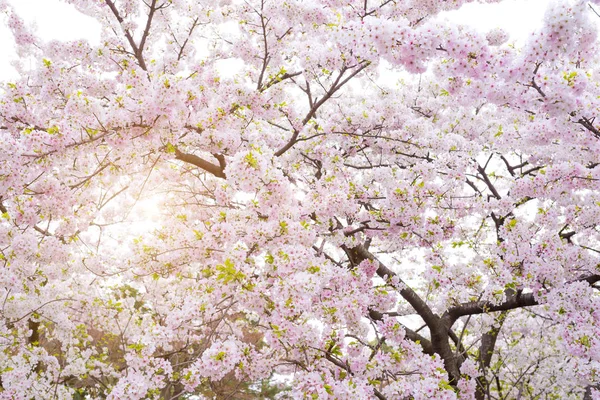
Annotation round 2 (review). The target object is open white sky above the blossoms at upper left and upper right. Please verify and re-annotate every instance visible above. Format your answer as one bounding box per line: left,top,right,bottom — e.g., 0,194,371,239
0,0,550,81
